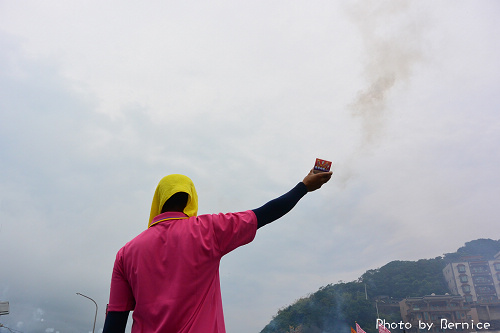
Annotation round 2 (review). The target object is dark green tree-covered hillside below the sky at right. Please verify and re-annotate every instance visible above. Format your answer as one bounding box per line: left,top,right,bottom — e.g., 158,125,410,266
261,239,500,333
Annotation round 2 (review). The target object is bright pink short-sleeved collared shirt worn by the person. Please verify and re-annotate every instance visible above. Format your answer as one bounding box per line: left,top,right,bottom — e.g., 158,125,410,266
108,210,257,333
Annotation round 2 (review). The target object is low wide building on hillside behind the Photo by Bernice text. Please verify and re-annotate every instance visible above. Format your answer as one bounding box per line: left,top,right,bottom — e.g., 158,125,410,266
399,294,476,333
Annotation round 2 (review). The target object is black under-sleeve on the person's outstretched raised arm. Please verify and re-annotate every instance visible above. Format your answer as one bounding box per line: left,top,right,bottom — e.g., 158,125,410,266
253,182,307,229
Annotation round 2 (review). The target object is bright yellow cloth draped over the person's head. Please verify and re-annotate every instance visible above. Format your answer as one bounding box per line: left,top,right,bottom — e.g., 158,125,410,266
148,175,198,228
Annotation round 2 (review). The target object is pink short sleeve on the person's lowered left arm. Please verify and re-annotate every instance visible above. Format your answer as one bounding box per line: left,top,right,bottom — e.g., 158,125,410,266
108,248,135,311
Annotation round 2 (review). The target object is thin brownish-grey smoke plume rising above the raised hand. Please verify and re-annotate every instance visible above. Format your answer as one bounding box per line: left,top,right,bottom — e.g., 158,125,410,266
339,0,425,185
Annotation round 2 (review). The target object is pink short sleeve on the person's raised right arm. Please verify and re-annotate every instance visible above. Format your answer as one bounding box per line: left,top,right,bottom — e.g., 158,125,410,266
212,210,257,255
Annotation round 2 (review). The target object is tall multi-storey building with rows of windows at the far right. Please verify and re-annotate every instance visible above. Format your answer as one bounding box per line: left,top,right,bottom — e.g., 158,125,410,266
443,252,500,332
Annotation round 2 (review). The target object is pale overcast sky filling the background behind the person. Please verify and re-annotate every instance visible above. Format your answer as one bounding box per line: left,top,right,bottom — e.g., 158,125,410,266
0,0,500,333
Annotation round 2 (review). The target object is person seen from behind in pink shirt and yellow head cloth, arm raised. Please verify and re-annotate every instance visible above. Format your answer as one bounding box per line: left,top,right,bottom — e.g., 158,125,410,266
103,170,332,333
